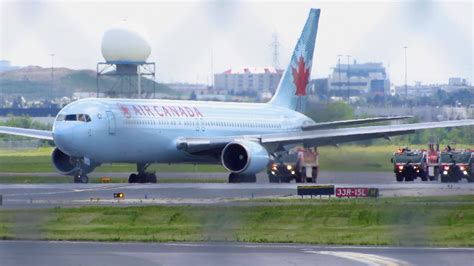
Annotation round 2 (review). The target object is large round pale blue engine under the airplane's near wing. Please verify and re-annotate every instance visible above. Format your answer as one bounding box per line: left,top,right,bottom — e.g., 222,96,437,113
221,141,270,175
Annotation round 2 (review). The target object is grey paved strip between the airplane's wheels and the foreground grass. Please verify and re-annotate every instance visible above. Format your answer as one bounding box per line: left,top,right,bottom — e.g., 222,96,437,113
0,182,474,208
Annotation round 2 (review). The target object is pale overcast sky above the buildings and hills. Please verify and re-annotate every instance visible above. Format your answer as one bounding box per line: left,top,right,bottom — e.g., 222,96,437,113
0,0,474,84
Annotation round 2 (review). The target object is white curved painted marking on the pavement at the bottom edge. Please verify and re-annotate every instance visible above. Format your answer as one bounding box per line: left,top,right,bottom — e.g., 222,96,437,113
305,251,410,266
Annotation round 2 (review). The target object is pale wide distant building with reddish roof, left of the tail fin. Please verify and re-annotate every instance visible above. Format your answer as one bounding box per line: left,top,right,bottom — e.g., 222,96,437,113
214,67,283,93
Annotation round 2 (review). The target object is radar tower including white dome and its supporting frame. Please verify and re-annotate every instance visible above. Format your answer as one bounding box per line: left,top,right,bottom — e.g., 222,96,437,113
97,20,156,98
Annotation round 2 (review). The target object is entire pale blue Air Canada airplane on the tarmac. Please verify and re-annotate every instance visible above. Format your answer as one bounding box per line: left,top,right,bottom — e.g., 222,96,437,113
0,9,474,183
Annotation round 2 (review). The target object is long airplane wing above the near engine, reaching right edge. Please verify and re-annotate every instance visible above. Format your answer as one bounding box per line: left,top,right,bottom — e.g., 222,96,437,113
177,119,474,154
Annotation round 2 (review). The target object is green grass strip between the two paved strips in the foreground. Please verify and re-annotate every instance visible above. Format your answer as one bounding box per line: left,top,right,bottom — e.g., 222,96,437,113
0,196,474,247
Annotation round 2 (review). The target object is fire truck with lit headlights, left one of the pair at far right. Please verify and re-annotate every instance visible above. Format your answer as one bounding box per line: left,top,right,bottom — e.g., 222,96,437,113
391,148,429,182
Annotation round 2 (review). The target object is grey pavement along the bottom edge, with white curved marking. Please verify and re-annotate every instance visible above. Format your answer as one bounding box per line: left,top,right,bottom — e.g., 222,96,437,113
0,241,474,266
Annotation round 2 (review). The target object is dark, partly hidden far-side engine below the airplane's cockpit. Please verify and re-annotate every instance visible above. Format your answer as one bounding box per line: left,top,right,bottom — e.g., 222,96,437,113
51,148,98,175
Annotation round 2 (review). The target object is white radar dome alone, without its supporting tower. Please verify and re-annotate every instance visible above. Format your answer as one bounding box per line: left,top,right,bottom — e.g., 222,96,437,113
101,20,151,62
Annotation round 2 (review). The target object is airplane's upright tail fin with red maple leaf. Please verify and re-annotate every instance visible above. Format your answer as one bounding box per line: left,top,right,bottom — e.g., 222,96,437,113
269,9,320,112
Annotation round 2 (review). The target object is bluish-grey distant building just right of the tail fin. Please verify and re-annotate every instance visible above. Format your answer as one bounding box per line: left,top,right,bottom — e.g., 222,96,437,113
328,61,390,97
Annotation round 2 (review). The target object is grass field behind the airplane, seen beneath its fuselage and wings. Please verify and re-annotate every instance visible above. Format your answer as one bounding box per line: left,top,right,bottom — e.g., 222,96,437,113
0,145,440,173
